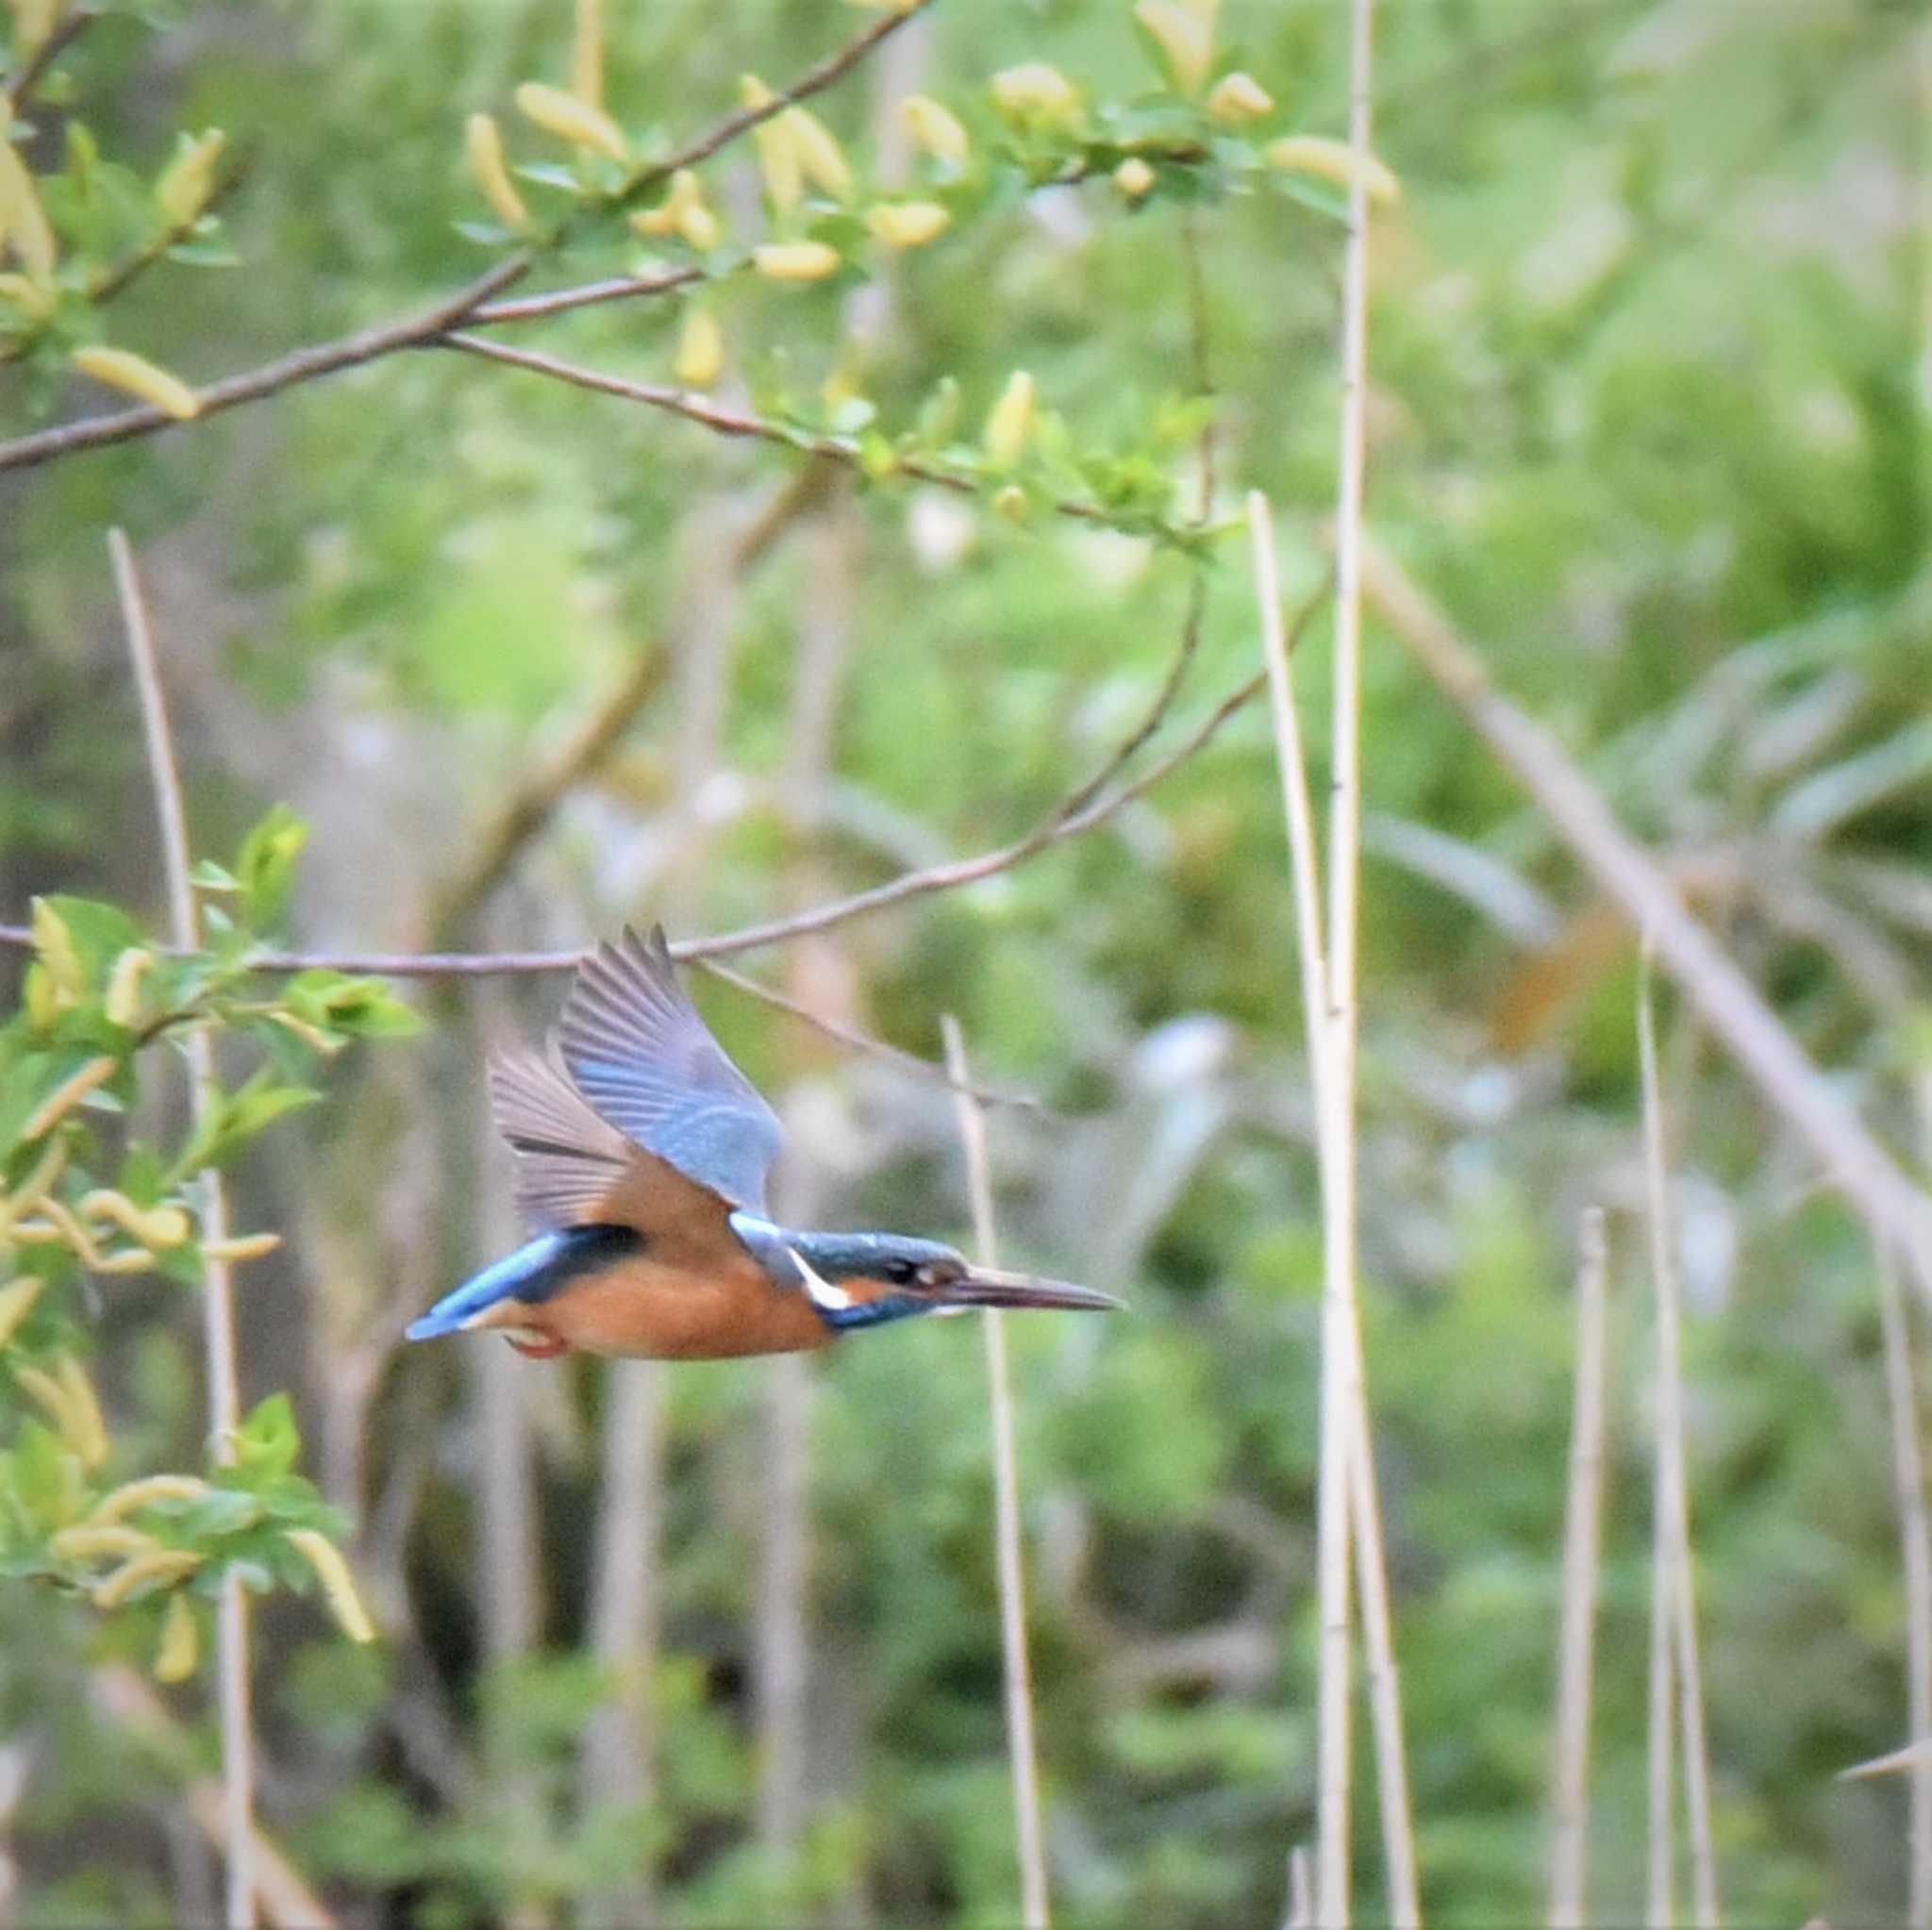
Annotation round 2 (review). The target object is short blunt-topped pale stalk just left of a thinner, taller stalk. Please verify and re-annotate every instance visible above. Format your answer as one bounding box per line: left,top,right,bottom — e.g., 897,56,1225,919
1549,1206,1607,1930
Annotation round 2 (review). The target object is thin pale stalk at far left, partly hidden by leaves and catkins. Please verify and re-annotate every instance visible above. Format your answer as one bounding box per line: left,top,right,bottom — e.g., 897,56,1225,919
108,529,255,1930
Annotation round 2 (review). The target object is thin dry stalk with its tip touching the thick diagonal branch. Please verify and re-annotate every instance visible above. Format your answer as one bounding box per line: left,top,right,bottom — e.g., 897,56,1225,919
1637,944,1718,1930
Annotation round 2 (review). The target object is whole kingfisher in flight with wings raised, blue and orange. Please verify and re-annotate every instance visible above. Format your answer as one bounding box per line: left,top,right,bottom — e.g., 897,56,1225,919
408,925,1121,1360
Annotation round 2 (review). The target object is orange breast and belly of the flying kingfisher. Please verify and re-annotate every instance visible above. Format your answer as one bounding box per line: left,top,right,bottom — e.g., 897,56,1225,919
514,1256,831,1360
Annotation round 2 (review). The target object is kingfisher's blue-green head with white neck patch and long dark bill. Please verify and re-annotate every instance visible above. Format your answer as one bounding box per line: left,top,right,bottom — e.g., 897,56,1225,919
732,1213,1121,1327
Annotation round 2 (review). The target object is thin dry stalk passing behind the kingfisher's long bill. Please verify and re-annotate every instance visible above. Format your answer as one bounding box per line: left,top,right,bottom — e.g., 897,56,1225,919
939,1012,1047,1930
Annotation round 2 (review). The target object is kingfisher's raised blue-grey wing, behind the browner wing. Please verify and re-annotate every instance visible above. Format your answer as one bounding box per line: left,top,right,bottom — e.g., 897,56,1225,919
557,925,782,1215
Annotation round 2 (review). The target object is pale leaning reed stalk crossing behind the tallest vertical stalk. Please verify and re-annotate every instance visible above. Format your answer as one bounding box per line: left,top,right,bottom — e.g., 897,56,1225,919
1248,491,1422,1926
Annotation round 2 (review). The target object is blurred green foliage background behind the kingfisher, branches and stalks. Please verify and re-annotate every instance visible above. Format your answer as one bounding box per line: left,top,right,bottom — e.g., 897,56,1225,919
0,0,1932,1926
